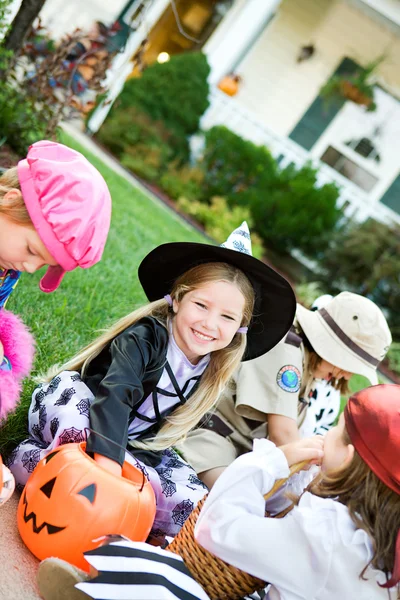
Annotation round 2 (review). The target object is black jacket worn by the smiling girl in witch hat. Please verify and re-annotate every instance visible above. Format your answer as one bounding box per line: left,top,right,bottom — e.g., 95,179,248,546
82,317,170,465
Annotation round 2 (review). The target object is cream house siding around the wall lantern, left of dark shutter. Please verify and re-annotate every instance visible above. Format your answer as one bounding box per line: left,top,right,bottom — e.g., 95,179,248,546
235,0,400,136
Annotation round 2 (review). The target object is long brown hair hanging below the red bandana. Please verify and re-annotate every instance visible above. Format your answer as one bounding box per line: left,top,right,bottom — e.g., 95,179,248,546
307,429,400,588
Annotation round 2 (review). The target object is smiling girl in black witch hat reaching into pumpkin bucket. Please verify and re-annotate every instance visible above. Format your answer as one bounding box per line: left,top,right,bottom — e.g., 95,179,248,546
8,223,295,537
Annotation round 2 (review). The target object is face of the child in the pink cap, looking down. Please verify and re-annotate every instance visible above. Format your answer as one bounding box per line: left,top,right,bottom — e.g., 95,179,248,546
0,214,57,273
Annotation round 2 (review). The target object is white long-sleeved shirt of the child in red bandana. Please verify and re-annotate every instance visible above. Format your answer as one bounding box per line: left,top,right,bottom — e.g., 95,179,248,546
195,440,332,598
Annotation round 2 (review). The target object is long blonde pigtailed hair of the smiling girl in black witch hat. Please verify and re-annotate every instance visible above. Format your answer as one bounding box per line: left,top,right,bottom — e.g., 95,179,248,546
45,263,254,450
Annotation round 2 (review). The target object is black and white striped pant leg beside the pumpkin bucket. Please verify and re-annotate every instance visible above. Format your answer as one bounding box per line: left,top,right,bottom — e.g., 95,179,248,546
76,541,209,600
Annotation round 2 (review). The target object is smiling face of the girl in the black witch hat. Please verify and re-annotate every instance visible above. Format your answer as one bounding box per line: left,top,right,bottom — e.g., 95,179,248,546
172,281,245,364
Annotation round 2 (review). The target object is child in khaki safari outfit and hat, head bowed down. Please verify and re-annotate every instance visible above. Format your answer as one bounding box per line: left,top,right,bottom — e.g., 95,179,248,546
180,292,392,487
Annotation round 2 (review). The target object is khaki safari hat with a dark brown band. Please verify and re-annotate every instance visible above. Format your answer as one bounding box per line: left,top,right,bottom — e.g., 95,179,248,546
296,292,392,385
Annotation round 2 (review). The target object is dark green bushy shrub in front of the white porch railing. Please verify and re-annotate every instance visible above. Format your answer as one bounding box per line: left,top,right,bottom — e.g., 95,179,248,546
203,126,341,256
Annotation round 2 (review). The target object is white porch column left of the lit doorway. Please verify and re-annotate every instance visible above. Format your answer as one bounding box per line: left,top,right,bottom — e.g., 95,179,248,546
87,0,169,133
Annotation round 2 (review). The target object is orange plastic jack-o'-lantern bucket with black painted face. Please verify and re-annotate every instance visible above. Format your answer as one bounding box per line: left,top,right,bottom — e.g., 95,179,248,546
18,443,155,570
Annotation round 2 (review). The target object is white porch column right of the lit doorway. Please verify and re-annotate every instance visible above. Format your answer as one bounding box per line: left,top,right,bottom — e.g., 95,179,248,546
203,0,281,83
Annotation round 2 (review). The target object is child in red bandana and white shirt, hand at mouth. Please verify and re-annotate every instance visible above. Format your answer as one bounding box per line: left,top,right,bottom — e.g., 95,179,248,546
195,385,400,600
